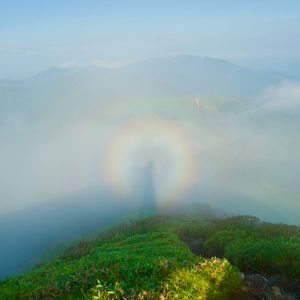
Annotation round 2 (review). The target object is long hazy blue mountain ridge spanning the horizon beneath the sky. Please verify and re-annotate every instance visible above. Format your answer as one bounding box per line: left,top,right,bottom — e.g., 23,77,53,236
0,55,286,113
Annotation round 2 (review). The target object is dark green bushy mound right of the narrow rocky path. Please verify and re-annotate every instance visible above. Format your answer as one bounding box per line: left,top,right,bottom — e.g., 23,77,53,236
204,217,300,279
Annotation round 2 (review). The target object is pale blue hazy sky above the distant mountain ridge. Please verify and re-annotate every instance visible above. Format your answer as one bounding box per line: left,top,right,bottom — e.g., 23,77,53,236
0,0,300,79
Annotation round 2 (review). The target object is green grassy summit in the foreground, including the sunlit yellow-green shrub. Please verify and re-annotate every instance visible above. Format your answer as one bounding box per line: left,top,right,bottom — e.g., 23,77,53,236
0,217,300,300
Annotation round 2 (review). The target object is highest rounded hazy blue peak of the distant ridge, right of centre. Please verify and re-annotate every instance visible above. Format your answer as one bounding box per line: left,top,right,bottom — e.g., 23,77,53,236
117,55,284,96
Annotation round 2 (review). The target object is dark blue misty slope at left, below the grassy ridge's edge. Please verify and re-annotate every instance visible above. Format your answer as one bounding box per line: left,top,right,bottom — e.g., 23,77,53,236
0,188,134,278
